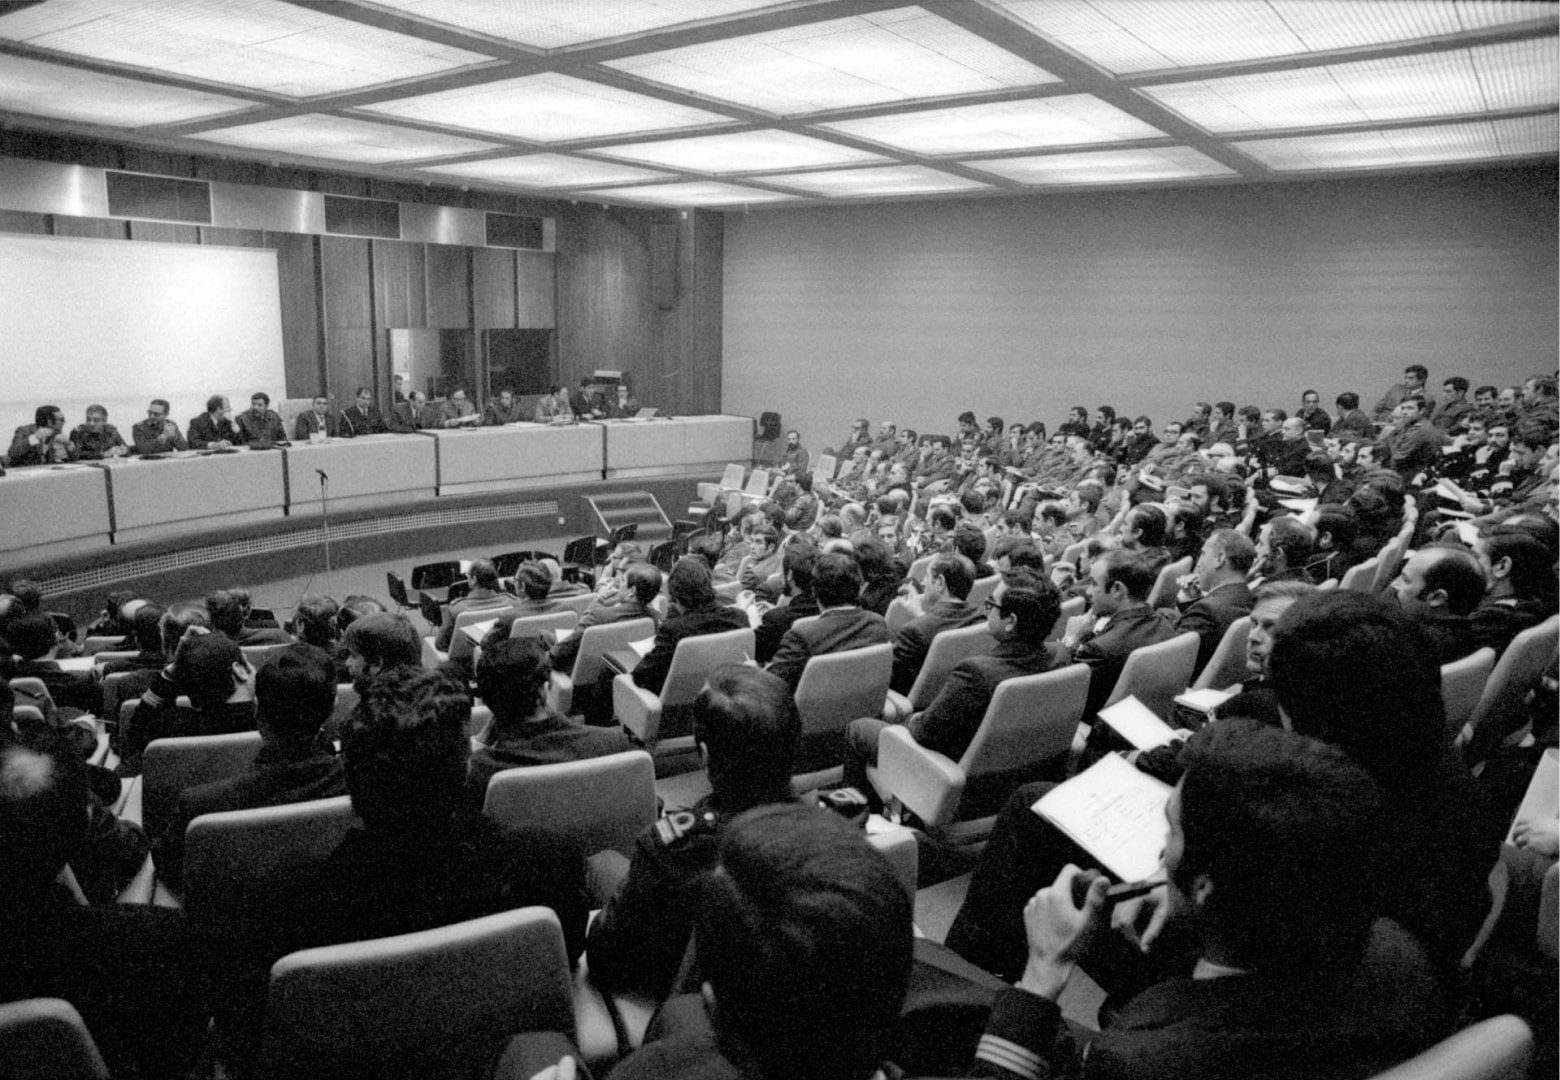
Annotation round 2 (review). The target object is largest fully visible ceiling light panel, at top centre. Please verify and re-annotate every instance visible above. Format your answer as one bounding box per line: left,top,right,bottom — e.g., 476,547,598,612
607,8,1058,115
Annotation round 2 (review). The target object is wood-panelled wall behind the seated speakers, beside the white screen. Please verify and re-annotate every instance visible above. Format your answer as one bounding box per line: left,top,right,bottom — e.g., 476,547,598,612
0,131,722,414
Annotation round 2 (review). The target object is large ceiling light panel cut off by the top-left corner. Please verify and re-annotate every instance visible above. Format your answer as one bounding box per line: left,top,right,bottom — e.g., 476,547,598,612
0,0,490,97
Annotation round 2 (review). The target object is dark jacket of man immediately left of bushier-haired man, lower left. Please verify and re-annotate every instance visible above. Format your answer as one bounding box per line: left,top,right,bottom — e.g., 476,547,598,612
151,743,346,888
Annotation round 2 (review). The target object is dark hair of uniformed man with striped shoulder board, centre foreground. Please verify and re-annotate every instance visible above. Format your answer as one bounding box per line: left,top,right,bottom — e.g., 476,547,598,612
693,663,802,813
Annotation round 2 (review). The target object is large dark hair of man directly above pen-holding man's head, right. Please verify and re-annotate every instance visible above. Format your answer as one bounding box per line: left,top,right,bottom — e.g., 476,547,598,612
1268,592,1446,791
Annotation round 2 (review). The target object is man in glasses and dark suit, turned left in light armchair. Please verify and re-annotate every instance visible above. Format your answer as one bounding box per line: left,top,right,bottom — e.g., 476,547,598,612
844,570,1067,813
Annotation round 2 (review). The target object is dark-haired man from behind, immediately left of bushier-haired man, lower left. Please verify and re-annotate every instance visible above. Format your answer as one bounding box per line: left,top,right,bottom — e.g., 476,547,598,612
151,645,346,890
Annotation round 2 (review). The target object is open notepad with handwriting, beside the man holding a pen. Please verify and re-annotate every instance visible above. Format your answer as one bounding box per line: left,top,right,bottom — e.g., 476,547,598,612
1031,754,1170,882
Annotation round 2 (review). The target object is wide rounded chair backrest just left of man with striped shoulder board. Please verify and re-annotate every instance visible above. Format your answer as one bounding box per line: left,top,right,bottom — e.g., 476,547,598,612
482,751,655,855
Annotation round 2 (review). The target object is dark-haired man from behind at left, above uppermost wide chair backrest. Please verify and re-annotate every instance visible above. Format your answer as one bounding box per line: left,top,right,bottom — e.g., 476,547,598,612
119,624,254,776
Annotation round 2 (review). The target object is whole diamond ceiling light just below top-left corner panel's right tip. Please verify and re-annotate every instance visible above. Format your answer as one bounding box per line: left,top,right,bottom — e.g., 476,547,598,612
363,73,732,142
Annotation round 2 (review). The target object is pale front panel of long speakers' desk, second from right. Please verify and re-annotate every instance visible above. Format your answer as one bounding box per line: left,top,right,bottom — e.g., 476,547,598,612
424,423,602,495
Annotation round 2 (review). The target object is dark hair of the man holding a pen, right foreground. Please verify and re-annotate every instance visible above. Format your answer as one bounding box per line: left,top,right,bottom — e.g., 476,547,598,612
1173,718,1381,977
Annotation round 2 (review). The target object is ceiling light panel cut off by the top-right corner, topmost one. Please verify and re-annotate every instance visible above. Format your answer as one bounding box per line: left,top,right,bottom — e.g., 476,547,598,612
995,0,1555,75
